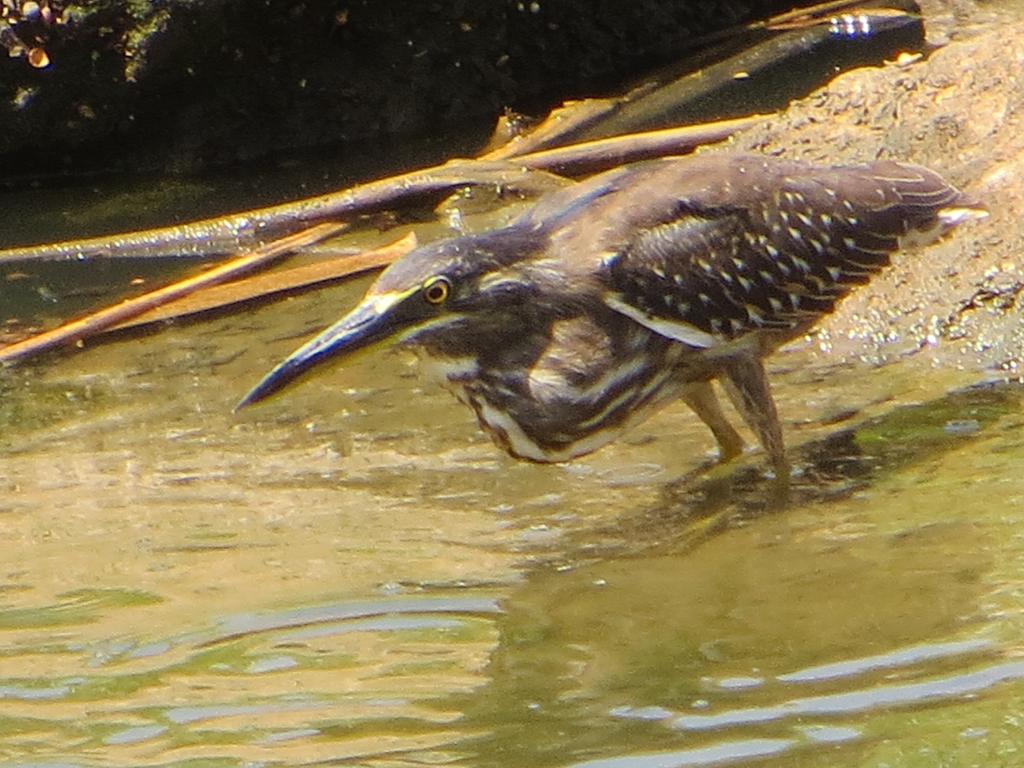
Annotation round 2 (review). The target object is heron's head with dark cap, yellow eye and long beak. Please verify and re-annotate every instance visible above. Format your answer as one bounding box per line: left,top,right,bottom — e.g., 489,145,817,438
238,227,537,408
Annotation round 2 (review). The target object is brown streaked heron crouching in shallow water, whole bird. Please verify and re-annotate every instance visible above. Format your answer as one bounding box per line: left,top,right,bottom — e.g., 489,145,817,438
240,155,984,478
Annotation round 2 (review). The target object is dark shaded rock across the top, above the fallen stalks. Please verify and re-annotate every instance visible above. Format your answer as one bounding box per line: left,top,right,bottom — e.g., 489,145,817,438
0,0,792,180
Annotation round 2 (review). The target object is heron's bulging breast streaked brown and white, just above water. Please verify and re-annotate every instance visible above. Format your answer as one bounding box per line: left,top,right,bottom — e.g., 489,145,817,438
407,313,704,462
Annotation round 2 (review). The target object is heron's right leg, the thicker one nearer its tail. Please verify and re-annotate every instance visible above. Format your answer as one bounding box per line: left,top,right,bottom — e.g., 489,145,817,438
722,350,790,483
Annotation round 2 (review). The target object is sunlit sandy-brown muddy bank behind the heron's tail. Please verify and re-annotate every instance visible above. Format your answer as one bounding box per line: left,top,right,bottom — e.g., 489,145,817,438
733,2,1024,378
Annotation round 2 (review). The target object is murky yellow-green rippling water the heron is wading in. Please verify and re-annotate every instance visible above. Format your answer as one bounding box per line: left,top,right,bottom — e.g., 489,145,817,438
0,249,1024,767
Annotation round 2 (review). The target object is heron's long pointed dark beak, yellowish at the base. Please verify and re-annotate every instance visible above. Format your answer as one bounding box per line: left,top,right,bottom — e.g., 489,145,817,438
234,295,400,411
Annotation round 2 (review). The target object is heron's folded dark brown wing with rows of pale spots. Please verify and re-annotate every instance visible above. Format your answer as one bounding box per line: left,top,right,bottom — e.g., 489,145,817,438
604,157,961,347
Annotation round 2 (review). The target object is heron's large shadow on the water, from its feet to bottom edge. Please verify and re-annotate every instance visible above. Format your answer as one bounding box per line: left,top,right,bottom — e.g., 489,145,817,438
448,385,1024,768
